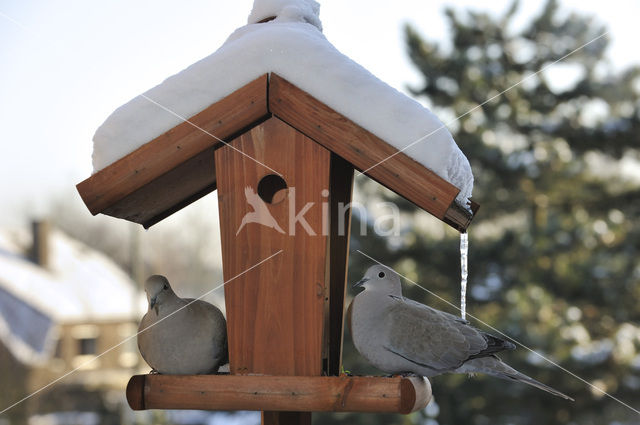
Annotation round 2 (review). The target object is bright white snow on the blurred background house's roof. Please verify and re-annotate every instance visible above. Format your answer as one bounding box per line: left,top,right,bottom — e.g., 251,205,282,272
0,229,145,322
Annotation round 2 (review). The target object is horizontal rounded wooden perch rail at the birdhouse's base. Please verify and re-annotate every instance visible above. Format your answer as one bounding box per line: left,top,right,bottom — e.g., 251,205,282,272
127,375,431,414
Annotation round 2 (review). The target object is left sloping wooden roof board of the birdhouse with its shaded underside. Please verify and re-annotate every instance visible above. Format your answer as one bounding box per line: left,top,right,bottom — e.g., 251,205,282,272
77,75,269,222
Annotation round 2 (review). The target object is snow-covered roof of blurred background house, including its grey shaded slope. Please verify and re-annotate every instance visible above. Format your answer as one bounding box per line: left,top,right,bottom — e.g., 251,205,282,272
0,230,144,363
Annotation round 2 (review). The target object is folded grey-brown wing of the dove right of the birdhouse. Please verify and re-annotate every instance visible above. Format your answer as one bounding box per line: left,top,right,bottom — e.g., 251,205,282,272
385,297,512,372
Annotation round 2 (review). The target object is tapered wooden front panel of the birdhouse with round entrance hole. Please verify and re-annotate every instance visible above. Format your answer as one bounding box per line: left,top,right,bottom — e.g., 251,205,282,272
215,118,330,375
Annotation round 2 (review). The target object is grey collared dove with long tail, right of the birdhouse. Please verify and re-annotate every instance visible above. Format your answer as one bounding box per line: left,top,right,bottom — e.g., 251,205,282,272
348,265,573,400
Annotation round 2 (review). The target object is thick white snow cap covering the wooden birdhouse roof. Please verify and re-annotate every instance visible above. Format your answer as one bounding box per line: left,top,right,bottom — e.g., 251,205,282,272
93,0,473,206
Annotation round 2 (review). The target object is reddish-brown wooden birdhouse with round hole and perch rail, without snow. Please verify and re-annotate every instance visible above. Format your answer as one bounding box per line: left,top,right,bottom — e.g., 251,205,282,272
78,74,476,424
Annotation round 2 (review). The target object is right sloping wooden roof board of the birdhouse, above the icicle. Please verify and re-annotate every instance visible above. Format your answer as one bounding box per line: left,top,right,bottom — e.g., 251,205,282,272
269,74,470,228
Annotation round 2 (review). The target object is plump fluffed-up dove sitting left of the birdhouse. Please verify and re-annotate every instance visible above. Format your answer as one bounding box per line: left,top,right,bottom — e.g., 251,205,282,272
138,275,229,375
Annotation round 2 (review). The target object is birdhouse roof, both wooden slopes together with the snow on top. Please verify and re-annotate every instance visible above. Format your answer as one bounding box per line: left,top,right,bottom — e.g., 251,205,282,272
78,14,473,229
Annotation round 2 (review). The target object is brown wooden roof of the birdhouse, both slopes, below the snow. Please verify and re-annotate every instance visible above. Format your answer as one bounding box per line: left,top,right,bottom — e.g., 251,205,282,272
77,73,478,231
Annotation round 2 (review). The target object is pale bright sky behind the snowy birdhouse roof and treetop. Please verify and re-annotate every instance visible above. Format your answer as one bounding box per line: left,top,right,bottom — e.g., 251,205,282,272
0,0,640,226
